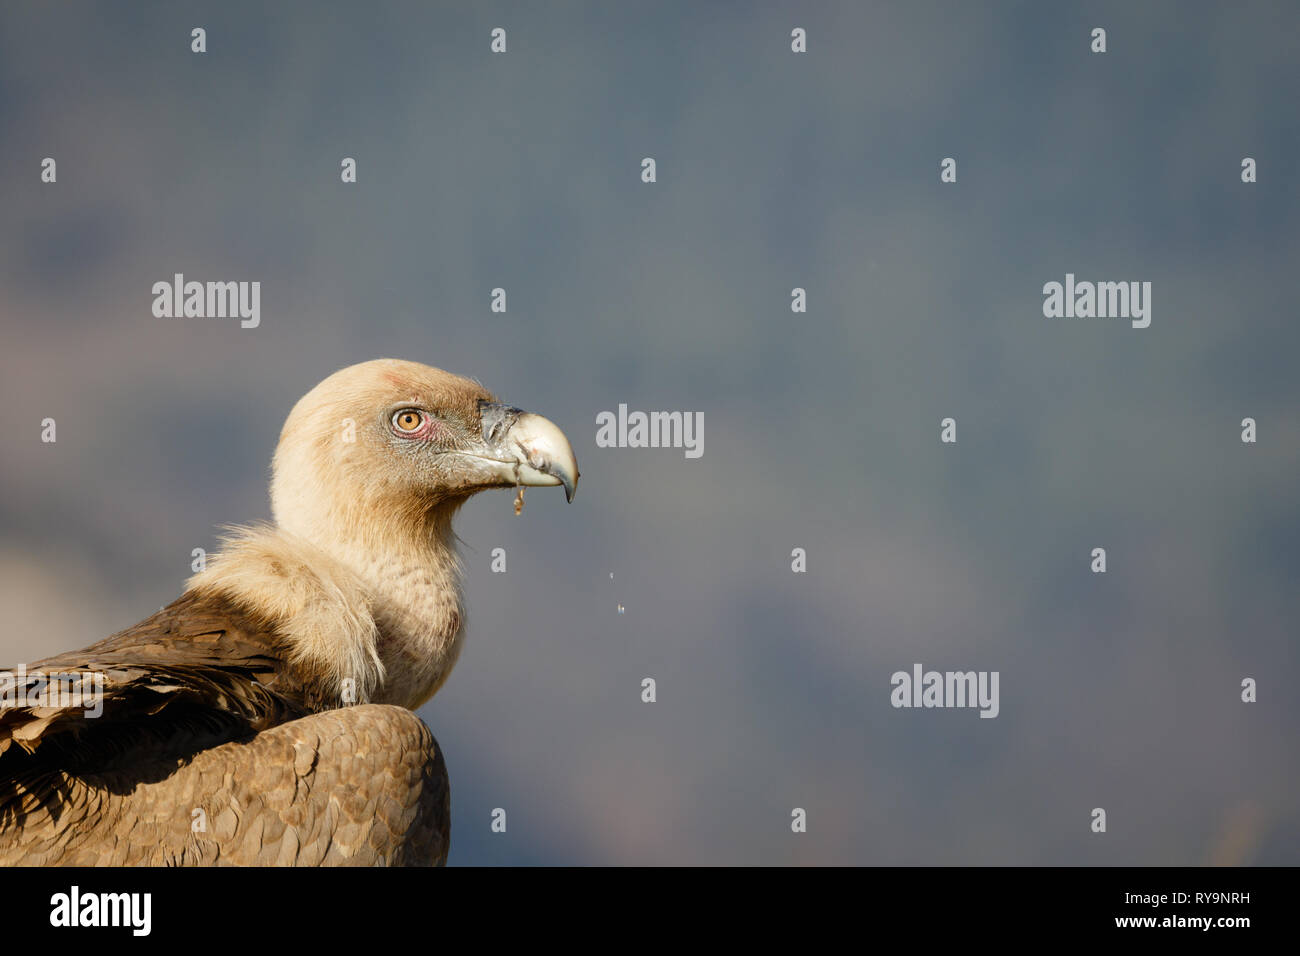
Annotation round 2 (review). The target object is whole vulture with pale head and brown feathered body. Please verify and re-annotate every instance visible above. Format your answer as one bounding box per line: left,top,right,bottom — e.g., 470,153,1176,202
0,359,579,866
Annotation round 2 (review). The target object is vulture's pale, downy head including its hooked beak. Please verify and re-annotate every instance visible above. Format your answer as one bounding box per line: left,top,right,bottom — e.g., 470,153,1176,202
270,359,579,540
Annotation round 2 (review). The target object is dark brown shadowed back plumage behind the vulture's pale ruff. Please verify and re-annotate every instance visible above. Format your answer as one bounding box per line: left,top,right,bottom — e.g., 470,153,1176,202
0,592,340,840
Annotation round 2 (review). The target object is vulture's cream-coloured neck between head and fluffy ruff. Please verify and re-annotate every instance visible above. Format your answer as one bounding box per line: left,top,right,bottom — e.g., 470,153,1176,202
286,501,464,709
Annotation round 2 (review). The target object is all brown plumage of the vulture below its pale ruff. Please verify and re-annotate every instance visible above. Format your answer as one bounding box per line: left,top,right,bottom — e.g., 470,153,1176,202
0,592,450,865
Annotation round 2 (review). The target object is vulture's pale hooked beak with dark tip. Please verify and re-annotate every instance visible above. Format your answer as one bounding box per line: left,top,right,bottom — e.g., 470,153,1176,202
478,401,579,501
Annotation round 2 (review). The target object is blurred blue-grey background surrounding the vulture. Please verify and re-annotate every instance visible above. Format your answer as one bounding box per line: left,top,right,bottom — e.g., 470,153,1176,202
0,3,1300,865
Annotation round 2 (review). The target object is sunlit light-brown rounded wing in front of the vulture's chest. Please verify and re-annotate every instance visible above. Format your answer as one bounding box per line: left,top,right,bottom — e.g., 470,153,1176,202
0,704,450,866
